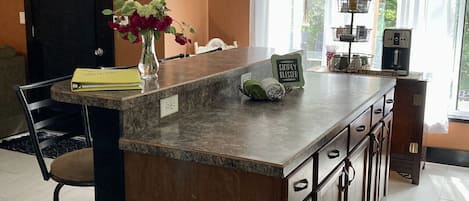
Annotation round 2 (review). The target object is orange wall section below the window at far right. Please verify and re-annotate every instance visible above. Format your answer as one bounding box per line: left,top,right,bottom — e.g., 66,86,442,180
424,122,469,151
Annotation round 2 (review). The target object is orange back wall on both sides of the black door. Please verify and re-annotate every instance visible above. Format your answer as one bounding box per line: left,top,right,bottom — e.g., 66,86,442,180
0,0,245,65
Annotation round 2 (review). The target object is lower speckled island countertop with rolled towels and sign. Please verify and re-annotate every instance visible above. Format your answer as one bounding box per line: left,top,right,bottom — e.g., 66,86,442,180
120,72,395,177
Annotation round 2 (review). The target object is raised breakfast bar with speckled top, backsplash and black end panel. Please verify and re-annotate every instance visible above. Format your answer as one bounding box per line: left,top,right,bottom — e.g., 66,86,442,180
51,48,294,201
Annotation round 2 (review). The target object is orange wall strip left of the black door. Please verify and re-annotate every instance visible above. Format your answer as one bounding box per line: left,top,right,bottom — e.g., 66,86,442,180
0,0,26,54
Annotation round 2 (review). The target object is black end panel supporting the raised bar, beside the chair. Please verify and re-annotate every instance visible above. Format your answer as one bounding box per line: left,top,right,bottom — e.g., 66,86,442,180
88,107,125,201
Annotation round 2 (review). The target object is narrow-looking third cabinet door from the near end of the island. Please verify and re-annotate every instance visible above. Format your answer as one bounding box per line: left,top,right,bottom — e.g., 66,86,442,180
368,122,383,201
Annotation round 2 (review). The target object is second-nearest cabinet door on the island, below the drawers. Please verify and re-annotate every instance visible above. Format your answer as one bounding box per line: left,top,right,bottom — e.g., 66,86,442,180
346,137,370,201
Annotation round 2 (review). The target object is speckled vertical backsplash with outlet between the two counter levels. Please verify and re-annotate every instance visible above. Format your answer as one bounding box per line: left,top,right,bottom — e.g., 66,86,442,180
122,61,272,136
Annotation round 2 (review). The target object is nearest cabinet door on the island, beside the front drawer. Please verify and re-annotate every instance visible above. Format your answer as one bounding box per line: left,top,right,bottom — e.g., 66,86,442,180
314,163,346,201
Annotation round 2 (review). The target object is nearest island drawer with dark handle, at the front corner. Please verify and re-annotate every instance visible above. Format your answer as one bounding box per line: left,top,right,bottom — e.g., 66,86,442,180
288,159,313,201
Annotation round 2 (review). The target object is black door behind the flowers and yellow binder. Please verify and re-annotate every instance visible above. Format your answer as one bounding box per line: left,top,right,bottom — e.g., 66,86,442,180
25,0,114,83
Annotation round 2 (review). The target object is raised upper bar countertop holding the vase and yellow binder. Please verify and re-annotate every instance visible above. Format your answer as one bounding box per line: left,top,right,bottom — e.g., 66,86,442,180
51,47,287,110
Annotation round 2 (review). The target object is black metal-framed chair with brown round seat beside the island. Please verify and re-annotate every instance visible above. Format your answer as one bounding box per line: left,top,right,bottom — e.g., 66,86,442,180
15,76,94,201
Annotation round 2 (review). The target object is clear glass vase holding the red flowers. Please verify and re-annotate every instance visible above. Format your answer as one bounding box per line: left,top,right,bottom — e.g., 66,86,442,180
138,30,160,80
